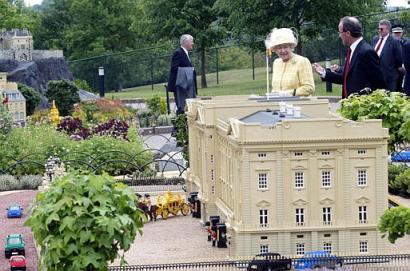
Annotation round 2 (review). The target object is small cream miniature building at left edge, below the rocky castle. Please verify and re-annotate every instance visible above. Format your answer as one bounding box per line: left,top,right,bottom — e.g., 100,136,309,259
0,72,26,125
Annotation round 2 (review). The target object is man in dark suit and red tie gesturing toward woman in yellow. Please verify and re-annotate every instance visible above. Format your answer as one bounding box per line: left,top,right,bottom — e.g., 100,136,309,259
313,17,386,98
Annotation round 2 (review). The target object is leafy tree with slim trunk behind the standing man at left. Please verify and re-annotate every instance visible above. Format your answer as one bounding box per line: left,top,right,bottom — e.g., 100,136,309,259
136,0,226,88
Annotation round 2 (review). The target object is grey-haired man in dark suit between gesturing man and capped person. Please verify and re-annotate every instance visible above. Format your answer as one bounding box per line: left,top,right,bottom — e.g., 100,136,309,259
371,20,403,91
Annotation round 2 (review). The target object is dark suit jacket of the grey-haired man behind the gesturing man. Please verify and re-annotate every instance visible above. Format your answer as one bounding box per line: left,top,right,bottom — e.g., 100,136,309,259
372,35,403,91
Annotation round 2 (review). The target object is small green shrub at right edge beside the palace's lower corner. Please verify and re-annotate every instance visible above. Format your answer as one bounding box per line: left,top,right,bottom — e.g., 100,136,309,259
379,207,410,243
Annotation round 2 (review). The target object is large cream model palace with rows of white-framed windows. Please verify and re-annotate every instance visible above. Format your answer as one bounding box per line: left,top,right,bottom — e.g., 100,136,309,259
187,96,388,256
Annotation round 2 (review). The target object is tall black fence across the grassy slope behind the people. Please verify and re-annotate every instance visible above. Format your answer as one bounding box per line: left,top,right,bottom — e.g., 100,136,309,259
69,9,410,92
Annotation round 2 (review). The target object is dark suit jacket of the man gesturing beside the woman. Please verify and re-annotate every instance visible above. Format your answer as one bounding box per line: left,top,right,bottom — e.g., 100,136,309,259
323,40,386,98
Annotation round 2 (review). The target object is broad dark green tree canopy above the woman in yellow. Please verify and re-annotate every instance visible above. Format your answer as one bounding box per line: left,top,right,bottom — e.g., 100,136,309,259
217,0,383,50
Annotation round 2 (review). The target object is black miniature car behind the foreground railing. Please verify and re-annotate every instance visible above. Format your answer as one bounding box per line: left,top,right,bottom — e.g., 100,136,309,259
246,253,292,271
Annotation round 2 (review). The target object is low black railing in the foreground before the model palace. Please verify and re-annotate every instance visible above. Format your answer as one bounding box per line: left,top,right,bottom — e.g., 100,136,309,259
109,254,410,271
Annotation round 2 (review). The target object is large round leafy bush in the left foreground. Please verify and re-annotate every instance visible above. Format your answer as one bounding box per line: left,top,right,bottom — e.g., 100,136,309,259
25,171,144,271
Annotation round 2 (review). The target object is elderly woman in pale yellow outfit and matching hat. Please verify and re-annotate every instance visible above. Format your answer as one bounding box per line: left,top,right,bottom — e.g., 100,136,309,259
266,28,315,96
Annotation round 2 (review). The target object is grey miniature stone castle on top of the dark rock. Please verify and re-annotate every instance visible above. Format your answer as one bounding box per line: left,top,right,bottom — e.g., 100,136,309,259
0,28,63,61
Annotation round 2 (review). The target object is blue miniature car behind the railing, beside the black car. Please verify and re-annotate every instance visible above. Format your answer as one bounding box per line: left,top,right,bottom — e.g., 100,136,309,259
294,251,343,270
